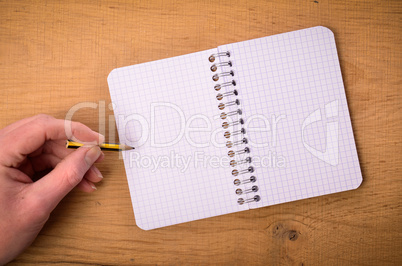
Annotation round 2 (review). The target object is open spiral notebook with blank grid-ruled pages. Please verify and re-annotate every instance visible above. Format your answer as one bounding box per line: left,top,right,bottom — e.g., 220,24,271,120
108,27,362,230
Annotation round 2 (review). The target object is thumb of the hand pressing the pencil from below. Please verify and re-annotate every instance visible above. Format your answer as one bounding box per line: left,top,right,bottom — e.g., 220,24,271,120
31,146,102,211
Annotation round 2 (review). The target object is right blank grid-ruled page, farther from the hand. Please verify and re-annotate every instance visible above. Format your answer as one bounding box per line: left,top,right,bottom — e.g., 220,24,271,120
218,27,362,208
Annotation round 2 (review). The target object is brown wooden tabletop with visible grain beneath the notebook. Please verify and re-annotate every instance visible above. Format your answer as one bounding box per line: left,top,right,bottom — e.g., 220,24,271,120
0,0,402,265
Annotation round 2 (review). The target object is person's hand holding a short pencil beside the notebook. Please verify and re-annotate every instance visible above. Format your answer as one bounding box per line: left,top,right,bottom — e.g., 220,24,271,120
0,115,104,265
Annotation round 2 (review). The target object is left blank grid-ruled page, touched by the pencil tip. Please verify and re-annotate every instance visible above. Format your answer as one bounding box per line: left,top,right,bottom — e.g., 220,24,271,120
108,49,248,229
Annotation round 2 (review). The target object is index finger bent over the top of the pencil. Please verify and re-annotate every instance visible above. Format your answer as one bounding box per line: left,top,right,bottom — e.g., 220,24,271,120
0,115,104,167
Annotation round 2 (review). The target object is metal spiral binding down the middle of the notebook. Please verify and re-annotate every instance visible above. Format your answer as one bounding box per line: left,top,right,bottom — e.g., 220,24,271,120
208,51,261,205
